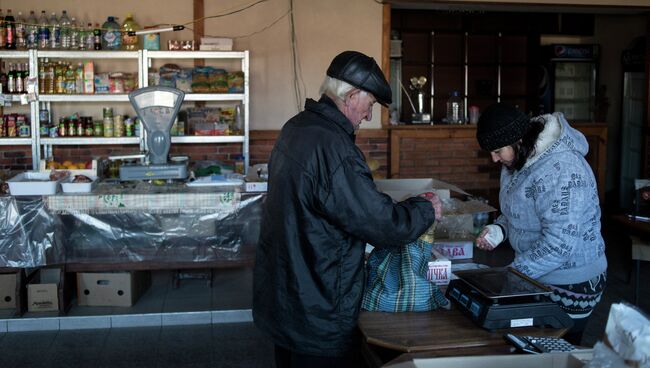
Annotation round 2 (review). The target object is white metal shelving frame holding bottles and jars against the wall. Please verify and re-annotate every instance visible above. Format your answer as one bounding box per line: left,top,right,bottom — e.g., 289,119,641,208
0,50,250,169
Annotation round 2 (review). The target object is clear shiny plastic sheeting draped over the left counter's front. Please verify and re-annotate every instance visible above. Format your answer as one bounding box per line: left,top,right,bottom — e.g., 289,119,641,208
0,193,265,267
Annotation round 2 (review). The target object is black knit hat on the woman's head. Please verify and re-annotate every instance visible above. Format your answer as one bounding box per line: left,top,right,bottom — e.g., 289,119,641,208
476,103,530,151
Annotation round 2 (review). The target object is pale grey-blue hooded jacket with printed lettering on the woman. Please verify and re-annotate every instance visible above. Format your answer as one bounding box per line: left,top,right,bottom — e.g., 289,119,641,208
496,112,607,285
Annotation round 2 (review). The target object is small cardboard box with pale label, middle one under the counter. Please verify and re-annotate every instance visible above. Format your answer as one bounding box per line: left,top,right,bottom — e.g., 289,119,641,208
27,268,63,312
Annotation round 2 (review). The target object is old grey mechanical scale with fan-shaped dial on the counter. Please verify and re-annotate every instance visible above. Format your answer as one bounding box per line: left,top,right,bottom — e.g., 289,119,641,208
120,86,187,181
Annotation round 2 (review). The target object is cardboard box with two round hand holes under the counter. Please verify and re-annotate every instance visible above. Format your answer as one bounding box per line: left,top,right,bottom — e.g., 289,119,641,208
77,271,151,307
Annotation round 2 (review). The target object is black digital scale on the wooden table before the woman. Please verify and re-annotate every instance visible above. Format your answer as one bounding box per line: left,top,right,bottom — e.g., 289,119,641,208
446,267,573,330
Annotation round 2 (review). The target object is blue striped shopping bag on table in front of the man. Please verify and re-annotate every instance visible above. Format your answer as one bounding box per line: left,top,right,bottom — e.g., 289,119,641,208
361,239,450,312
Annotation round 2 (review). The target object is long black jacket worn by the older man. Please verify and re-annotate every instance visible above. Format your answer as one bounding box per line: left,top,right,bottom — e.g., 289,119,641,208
253,96,435,356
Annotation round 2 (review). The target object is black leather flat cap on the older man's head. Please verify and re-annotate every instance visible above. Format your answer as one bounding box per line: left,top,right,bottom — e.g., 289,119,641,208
327,51,393,106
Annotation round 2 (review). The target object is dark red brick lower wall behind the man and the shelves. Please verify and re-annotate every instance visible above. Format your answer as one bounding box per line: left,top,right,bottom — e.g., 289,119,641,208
0,129,498,203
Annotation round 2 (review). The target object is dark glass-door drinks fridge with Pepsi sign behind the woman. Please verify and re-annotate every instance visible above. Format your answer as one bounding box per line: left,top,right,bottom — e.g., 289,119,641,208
541,44,600,121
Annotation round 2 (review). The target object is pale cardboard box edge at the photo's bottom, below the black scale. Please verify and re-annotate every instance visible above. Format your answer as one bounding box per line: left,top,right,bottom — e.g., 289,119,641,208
386,349,592,368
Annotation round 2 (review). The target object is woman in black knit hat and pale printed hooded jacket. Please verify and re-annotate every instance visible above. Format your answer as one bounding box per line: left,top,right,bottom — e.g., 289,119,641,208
476,103,607,344
